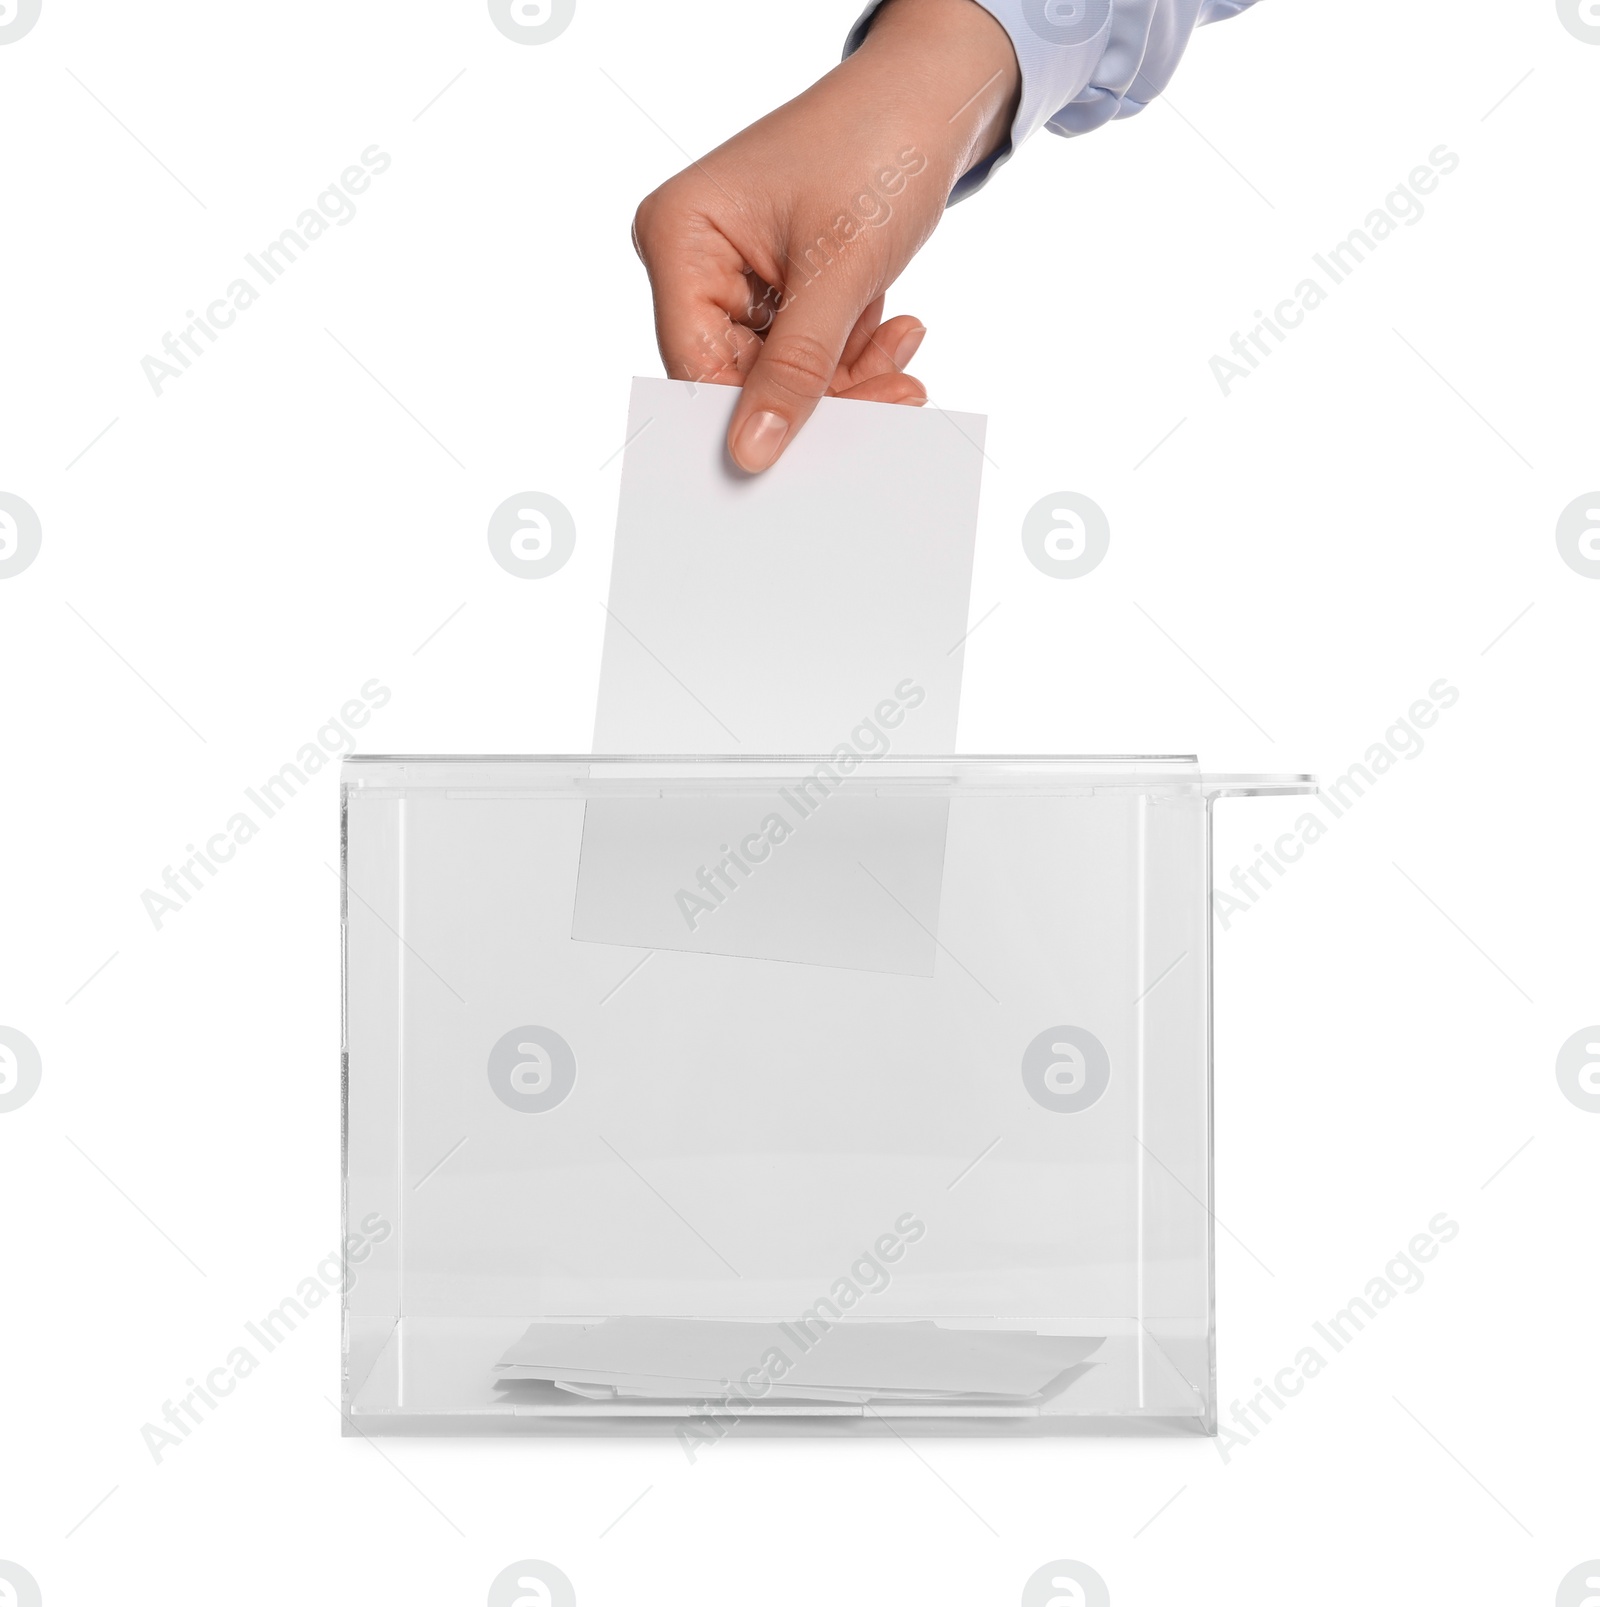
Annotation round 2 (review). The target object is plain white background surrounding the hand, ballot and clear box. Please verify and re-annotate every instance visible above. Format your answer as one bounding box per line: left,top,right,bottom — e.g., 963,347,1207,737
0,0,1600,1607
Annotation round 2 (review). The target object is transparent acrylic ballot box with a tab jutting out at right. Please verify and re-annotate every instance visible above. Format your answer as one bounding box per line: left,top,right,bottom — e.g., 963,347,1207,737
342,749,1312,1438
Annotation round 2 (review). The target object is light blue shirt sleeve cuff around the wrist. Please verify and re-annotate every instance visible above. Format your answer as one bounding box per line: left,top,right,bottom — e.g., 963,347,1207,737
845,0,1255,201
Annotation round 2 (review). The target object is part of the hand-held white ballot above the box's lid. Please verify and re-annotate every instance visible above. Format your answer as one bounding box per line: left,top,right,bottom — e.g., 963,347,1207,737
594,379,986,754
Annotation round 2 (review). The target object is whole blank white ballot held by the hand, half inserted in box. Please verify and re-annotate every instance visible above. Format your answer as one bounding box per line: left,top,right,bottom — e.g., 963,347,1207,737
572,379,985,975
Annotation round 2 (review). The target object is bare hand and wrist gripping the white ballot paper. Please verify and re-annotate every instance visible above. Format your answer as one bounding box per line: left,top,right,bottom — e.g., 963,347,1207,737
633,0,1018,472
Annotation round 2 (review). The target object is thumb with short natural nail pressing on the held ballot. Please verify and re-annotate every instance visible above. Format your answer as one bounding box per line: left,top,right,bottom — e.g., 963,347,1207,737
728,286,864,474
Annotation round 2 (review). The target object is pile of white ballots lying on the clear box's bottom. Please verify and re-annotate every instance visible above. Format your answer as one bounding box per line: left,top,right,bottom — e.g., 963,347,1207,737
495,1316,1100,1409
